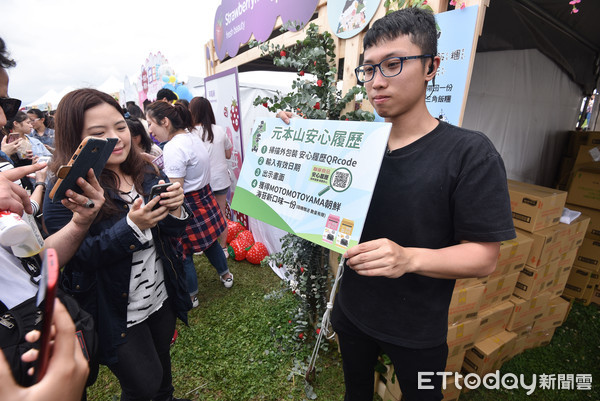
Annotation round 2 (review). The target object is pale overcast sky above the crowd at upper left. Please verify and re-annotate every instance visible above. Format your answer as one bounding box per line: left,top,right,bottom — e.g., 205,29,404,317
0,0,221,104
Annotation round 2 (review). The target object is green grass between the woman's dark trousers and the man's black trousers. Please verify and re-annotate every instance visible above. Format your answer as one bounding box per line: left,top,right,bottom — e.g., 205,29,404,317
88,256,344,401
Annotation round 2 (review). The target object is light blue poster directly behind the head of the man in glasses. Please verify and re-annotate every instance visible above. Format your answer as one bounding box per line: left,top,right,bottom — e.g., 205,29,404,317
426,5,479,125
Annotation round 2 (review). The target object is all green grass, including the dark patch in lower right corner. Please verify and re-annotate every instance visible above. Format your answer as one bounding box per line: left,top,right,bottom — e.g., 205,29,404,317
83,256,600,401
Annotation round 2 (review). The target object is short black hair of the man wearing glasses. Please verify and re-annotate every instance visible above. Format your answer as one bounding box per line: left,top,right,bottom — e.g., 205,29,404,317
363,7,437,56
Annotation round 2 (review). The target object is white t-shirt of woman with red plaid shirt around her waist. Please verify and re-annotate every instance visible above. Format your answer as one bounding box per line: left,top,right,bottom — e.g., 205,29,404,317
163,132,210,193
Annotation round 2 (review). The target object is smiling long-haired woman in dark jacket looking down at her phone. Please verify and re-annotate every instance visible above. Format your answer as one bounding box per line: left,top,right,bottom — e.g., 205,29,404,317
44,89,191,401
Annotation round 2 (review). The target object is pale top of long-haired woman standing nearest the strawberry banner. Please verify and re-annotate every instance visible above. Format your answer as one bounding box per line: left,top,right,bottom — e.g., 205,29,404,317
192,124,233,191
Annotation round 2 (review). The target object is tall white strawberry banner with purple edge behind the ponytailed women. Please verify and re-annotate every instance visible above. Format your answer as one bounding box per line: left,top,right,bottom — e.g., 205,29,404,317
204,68,248,227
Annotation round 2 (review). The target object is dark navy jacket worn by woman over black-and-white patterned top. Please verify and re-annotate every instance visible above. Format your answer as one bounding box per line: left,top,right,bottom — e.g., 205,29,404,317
44,169,192,365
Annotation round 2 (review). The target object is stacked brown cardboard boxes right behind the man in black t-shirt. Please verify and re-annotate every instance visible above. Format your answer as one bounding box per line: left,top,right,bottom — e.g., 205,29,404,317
376,180,600,401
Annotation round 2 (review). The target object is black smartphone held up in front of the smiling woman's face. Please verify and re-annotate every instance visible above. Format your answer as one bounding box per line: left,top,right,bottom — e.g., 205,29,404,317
49,136,118,203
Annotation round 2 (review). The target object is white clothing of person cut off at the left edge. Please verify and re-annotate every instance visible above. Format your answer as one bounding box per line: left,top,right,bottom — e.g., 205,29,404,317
0,245,38,309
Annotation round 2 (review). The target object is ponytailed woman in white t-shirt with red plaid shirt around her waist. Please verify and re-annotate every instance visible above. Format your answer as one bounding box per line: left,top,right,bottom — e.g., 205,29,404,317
146,102,233,306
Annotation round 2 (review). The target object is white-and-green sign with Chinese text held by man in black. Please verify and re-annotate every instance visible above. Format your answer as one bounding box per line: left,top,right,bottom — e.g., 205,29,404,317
231,118,391,252
